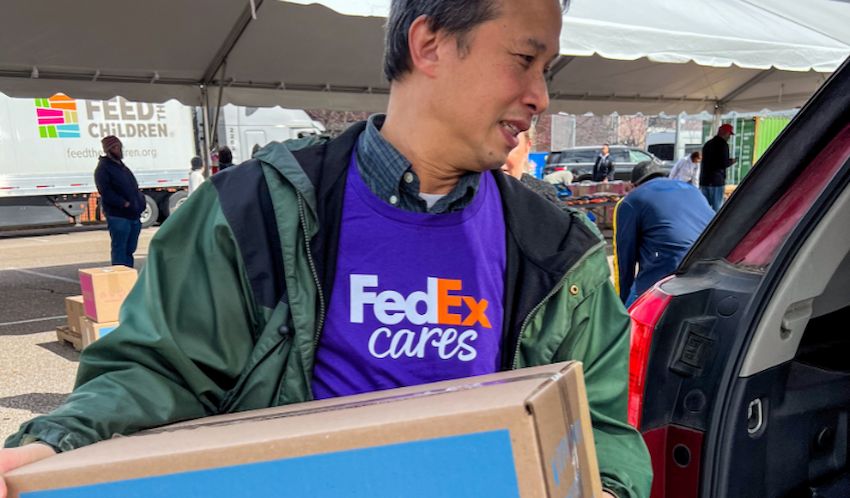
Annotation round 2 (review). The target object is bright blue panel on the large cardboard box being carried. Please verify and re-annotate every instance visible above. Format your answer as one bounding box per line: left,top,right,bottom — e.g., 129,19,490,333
21,430,519,498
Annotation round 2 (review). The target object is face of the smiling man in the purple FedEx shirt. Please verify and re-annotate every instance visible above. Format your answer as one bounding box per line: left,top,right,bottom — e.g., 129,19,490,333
430,0,561,171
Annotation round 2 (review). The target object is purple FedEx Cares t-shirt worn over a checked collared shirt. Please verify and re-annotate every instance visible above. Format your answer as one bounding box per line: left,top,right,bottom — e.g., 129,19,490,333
313,157,505,399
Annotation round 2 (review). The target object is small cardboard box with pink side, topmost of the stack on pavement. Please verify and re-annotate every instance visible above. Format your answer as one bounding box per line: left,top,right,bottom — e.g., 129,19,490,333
80,266,137,323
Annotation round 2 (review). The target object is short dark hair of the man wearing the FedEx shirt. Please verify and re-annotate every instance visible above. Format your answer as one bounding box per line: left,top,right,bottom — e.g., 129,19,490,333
384,0,570,81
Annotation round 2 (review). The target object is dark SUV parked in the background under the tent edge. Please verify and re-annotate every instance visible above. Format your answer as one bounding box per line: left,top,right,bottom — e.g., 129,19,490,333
543,145,673,182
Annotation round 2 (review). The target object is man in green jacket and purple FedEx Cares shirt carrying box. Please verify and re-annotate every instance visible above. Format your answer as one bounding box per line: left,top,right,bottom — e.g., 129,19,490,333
0,0,651,498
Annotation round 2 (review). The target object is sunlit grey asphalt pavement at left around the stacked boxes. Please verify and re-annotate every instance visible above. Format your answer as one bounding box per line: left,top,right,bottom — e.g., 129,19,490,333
0,228,156,442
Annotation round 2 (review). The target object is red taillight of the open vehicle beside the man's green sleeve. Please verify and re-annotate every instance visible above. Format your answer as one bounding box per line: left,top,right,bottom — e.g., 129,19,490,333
629,277,672,428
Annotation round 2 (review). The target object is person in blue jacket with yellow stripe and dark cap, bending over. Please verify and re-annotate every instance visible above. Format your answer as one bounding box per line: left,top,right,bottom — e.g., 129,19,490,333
614,161,714,306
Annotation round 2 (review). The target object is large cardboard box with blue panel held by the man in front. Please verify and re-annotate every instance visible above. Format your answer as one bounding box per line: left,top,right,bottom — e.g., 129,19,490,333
5,363,601,498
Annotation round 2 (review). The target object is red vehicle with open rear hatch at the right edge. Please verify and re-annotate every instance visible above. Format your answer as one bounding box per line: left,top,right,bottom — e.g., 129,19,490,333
629,59,850,498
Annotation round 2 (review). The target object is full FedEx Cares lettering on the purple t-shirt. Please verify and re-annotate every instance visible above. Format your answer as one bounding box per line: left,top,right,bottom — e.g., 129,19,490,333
349,274,490,362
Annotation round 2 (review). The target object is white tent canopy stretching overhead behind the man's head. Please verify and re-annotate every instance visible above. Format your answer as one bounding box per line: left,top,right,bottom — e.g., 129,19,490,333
0,0,850,114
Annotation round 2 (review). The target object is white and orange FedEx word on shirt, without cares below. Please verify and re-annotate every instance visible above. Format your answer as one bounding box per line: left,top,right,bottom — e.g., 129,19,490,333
350,274,492,329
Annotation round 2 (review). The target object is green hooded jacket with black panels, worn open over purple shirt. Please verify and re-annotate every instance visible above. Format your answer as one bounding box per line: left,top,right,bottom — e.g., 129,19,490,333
6,124,651,498
